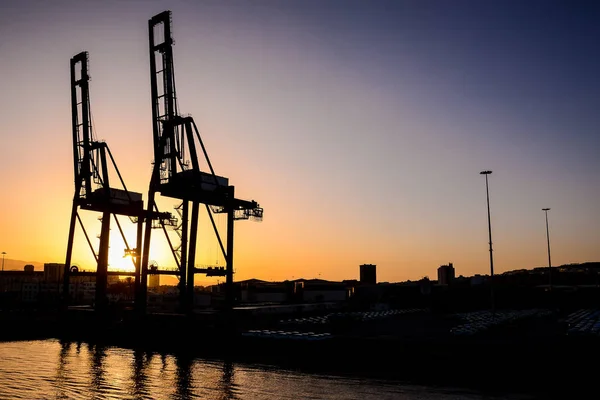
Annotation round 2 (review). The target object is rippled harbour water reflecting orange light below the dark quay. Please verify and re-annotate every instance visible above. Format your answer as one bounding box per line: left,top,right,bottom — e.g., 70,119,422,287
0,340,528,400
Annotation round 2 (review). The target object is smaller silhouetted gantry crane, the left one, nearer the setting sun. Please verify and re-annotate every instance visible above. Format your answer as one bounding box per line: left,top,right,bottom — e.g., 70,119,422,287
63,52,174,310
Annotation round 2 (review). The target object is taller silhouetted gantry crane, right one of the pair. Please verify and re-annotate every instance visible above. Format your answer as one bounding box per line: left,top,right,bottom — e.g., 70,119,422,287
140,11,263,307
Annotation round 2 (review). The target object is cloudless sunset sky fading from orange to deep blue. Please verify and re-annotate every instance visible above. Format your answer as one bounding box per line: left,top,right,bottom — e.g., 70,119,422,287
0,0,600,281
